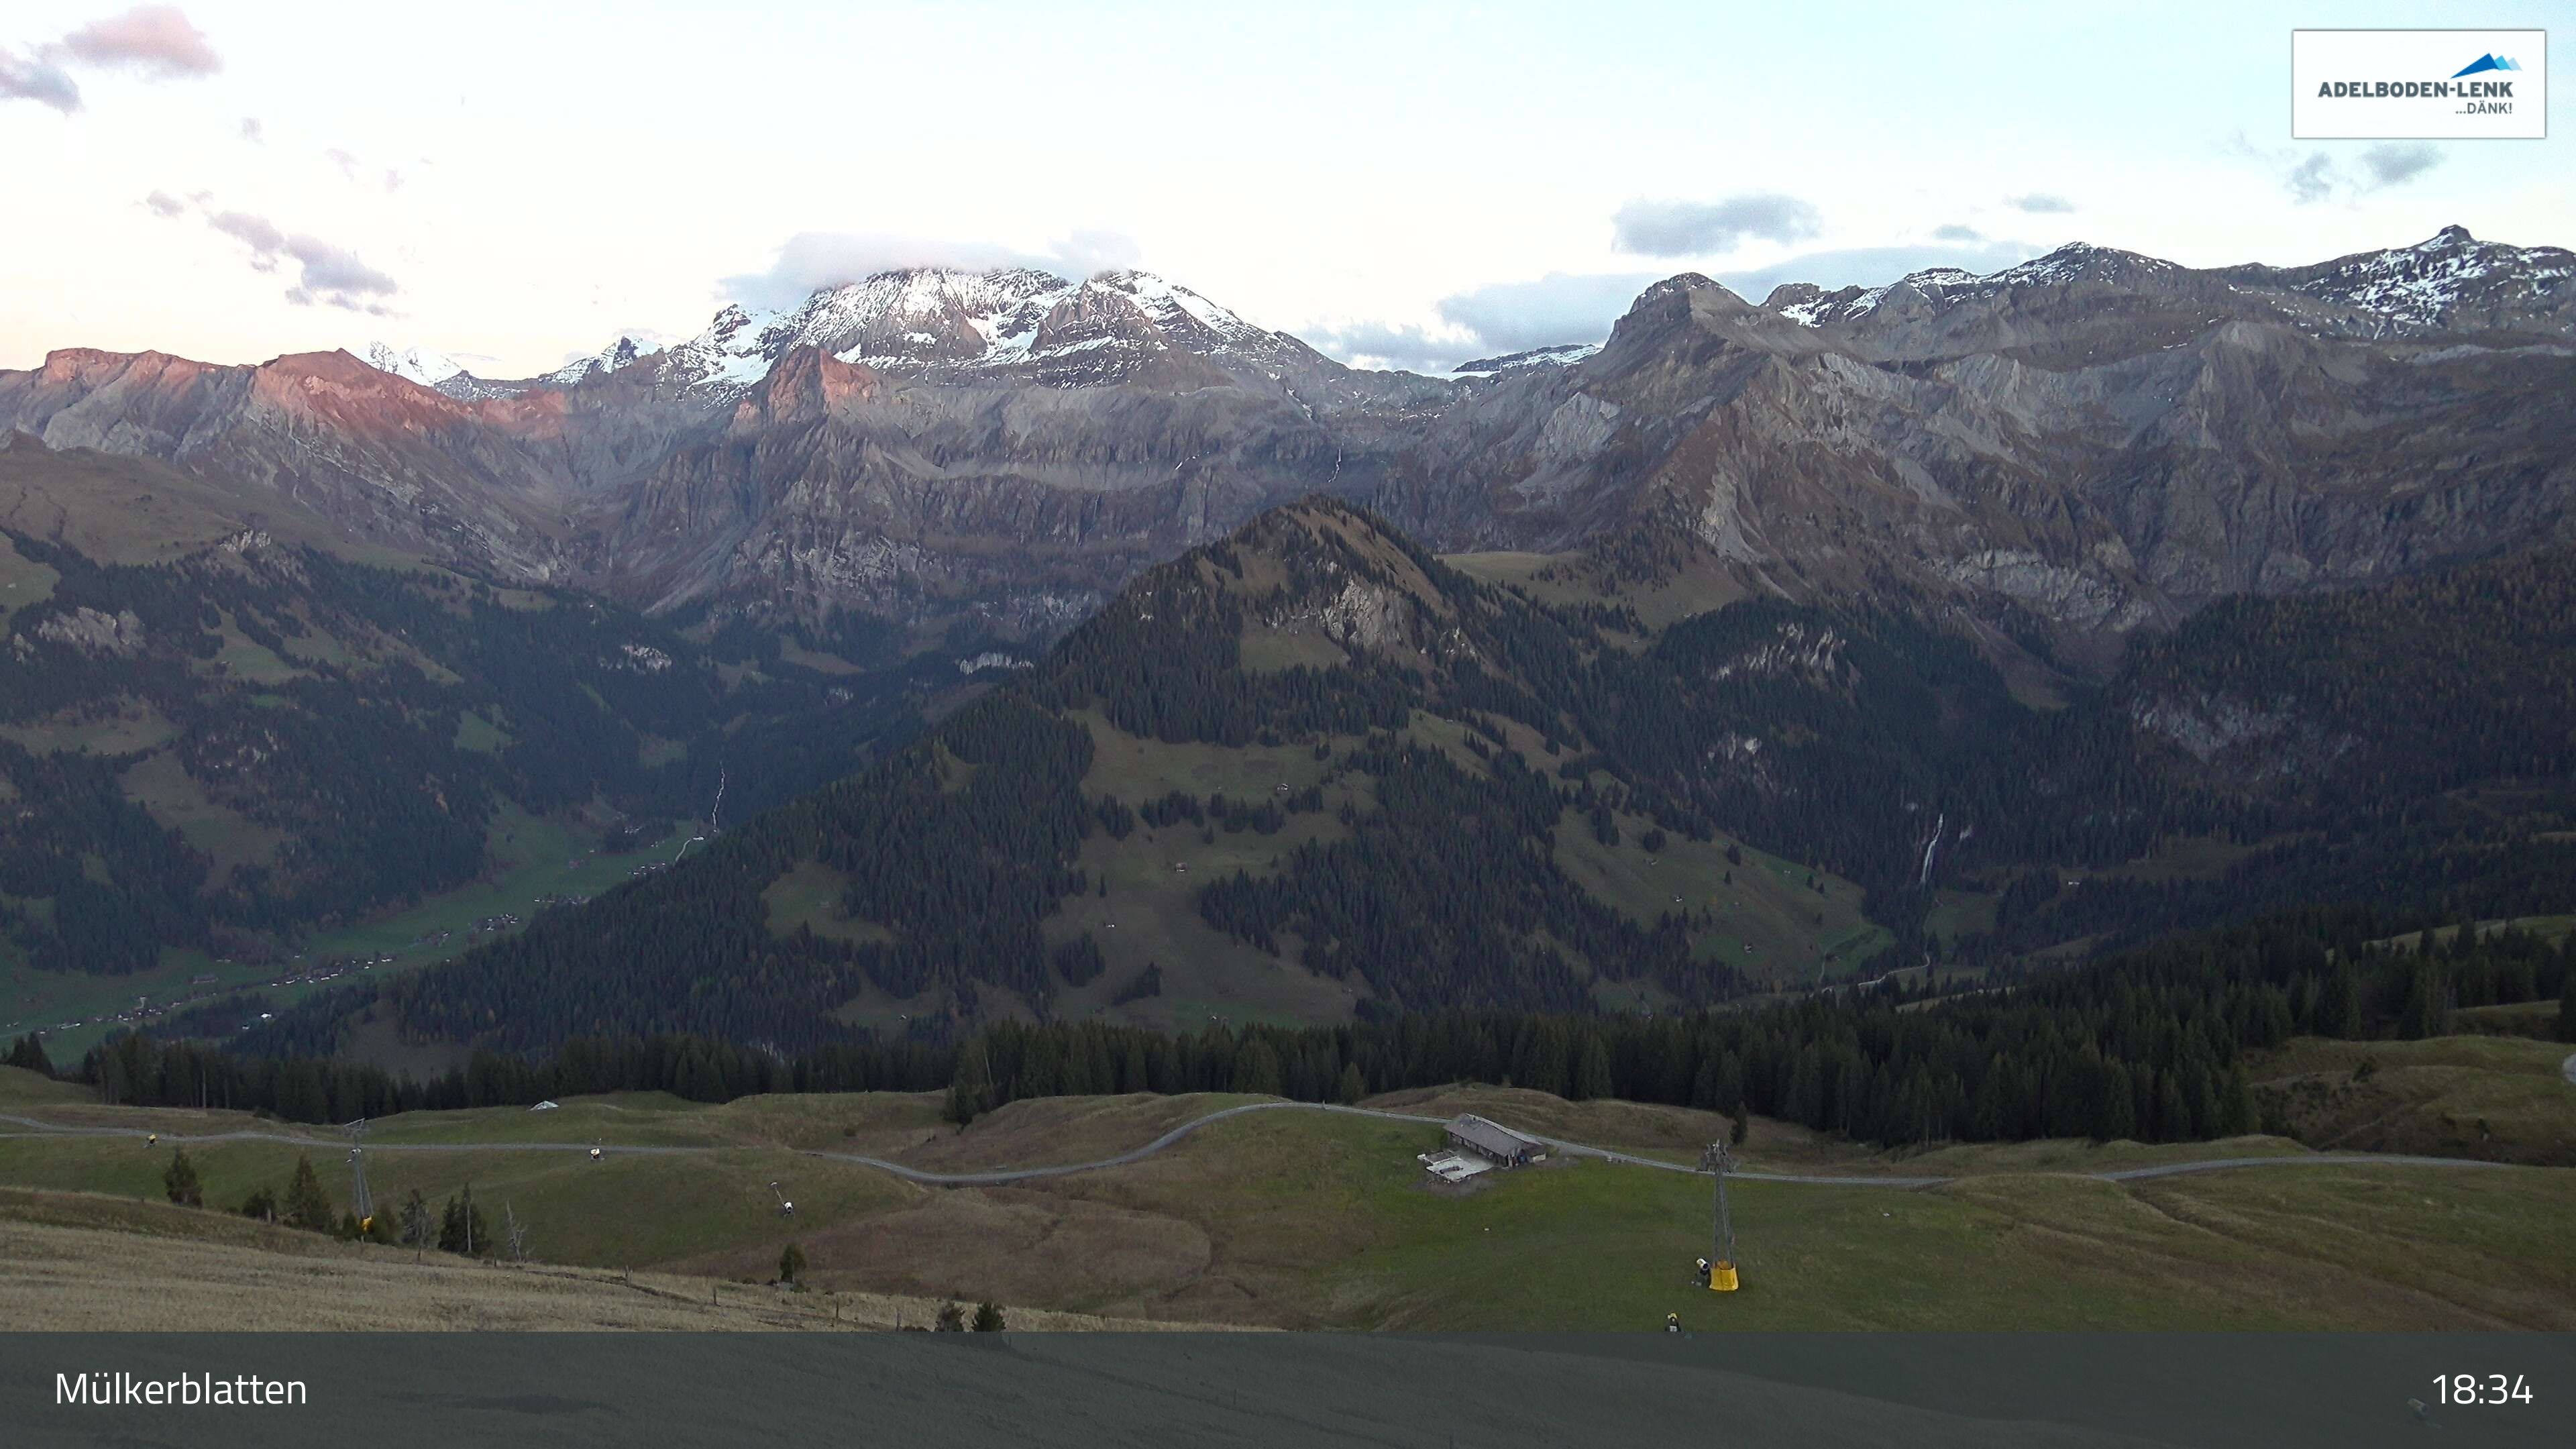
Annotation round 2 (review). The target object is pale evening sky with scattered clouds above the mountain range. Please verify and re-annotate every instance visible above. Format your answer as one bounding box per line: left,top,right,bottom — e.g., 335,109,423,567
0,0,2576,376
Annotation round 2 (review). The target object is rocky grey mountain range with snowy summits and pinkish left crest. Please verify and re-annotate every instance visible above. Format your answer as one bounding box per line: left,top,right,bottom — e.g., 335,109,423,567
0,227,2576,642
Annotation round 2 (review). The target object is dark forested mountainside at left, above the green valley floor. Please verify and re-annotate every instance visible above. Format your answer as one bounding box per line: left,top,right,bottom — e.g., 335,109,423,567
0,534,943,972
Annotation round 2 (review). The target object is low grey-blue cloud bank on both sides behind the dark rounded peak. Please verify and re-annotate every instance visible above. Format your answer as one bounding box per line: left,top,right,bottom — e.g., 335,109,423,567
1298,239,2043,374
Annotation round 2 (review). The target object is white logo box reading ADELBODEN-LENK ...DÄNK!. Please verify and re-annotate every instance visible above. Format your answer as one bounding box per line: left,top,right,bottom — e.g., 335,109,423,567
2290,31,2551,142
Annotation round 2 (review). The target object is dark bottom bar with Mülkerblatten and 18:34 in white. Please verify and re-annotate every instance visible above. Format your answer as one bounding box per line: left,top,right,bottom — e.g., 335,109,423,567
0,1333,2576,1449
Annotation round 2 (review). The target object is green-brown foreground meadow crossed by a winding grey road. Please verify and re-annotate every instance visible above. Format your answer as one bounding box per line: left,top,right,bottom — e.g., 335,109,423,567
0,1062,2576,1330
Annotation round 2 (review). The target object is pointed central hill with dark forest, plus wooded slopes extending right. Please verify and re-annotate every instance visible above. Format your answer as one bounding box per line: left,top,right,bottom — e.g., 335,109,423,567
226,500,2576,1052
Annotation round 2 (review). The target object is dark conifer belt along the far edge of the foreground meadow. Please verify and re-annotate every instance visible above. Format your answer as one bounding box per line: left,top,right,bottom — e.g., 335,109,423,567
35,908,2576,1144
